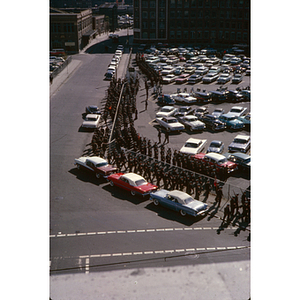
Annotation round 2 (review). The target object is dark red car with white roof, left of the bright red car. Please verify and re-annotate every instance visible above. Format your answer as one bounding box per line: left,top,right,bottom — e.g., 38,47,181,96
74,156,118,178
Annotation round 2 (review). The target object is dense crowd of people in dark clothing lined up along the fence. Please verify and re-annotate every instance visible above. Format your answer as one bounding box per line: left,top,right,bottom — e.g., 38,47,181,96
85,54,250,227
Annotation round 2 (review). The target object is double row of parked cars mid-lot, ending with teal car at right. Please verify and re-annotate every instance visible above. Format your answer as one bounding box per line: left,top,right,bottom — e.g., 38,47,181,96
155,105,251,132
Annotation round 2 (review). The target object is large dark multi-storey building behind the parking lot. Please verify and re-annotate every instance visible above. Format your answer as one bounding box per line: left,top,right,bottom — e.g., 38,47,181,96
133,0,250,47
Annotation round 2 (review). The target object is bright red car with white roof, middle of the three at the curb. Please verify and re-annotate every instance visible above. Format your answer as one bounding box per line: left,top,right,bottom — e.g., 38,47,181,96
107,173,158,196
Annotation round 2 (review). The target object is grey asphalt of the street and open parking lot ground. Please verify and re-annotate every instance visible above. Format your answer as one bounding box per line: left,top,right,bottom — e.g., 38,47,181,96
50,37,250,298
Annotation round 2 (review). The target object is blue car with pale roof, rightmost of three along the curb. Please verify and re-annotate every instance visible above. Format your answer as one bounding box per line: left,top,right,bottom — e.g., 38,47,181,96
150,189,208,217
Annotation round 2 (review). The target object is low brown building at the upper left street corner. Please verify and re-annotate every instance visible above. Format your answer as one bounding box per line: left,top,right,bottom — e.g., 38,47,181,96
50,8,100,54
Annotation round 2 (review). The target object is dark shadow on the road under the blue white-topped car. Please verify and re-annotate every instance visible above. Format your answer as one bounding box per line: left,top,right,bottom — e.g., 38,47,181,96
145,202,206,226
